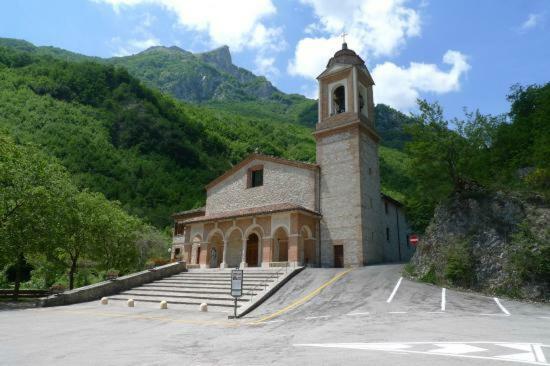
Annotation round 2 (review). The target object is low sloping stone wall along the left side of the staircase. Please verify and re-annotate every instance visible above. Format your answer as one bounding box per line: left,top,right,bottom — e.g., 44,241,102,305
38,262,186,306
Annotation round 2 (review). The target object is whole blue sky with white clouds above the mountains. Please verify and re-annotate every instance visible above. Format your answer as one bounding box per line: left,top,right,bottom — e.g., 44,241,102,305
0,0,550,117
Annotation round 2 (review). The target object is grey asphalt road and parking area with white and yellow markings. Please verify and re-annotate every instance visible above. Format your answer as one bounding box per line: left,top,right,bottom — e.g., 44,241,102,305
0,265,550,366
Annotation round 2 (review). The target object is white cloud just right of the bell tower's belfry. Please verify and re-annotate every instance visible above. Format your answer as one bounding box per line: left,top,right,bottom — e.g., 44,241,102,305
372,50,470,111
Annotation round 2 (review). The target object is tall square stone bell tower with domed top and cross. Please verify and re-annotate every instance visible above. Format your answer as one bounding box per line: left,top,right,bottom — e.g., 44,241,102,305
314,42,383,267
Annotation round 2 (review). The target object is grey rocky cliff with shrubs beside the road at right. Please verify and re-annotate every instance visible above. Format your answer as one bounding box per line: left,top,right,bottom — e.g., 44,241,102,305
407,192,550,301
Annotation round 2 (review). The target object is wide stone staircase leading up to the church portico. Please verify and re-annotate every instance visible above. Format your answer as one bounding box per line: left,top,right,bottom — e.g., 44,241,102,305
109,268,290,311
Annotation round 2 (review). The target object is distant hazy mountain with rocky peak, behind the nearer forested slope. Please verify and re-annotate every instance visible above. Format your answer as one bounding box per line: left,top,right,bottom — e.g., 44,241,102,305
0,38,411,145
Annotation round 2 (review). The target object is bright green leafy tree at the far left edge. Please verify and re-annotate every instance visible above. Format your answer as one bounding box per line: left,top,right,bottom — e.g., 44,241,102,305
0,135,74,298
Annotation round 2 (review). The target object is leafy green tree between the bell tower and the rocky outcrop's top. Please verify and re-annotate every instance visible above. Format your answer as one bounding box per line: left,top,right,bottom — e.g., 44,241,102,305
406,100,505,230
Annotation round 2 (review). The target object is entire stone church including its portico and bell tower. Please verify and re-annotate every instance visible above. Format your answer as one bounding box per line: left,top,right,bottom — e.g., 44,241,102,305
172,43,413,268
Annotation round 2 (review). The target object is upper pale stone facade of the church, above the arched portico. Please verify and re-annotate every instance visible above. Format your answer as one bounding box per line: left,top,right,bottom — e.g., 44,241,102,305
206,160,317,214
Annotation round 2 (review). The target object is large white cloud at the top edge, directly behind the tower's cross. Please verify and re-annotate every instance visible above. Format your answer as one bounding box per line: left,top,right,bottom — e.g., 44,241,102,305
288,0,421,78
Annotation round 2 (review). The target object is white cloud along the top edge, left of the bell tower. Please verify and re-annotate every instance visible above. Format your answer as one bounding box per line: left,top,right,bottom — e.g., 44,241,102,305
93,0,282,51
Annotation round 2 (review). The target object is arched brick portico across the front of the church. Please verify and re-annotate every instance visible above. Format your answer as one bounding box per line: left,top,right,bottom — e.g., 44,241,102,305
172,205,319,268
